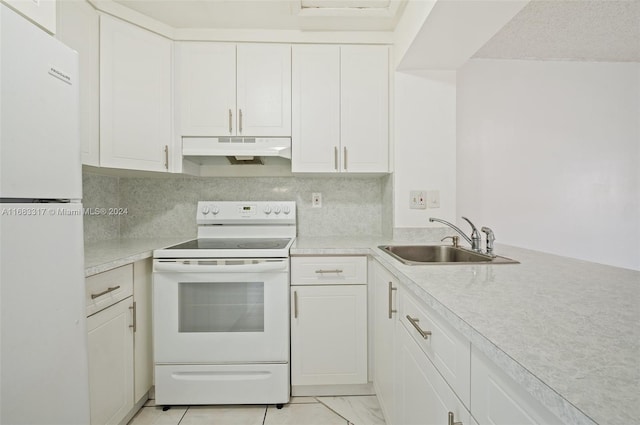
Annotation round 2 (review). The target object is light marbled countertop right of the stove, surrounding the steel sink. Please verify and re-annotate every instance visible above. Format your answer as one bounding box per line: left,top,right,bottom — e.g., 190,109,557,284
291,238,640,424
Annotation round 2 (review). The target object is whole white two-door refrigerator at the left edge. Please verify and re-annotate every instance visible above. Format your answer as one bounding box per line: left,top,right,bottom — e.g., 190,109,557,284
0,4,90,425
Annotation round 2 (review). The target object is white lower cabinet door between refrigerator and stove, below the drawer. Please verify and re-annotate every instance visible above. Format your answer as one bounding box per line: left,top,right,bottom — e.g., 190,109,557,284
87,297,133,425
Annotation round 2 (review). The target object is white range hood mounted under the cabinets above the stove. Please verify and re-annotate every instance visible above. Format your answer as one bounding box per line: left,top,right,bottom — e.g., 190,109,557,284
182,137,291,165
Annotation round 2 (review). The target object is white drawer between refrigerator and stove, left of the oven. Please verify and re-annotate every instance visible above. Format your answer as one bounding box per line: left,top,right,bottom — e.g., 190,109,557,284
85,264,133,316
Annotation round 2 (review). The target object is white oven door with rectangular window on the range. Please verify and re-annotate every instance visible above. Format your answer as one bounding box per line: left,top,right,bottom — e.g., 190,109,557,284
153,258,289,364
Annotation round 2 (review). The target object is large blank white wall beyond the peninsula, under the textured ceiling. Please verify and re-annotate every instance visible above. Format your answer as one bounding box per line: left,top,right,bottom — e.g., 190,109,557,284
457,60,640,270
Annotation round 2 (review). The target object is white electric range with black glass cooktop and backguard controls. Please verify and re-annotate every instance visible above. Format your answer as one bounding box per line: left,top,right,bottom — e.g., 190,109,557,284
153,201,296,405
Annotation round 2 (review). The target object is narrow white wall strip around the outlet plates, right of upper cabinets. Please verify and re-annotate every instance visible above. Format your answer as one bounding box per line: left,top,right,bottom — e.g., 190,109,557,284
393,71,456,228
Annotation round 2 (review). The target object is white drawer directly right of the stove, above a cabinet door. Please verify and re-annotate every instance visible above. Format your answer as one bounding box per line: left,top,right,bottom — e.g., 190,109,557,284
291,256,367,285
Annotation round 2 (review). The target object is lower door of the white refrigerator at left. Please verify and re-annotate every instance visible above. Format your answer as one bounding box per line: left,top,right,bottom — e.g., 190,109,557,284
0,203,89,425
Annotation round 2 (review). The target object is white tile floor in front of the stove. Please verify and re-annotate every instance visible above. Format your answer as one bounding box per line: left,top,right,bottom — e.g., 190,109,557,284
129,396,385,425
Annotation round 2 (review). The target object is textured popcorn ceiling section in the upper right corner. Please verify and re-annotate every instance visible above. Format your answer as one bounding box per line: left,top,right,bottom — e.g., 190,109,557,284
474,0,640,62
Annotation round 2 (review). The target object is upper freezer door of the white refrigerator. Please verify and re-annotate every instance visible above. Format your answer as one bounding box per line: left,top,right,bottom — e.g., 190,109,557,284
0,4,82,199
